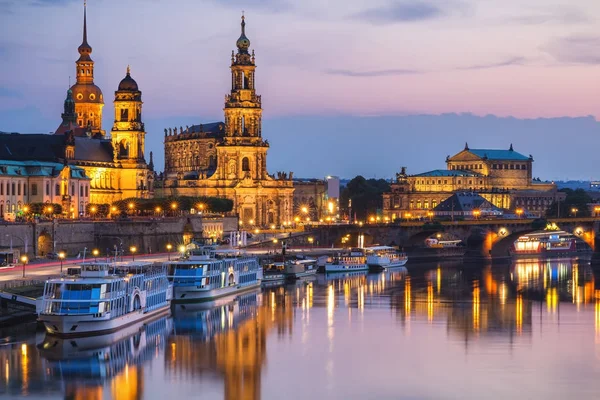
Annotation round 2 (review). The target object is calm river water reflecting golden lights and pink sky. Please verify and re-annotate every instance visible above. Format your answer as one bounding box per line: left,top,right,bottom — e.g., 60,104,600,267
0,260,600,400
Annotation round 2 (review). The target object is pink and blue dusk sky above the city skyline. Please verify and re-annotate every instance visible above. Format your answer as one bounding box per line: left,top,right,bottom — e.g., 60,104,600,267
0,0,600,180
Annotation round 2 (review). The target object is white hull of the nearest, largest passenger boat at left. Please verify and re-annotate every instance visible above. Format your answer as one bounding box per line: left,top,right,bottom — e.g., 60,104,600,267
38,304,171,337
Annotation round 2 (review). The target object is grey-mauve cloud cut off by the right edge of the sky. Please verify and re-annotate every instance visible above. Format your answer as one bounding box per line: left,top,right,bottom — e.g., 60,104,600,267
542,35,600,65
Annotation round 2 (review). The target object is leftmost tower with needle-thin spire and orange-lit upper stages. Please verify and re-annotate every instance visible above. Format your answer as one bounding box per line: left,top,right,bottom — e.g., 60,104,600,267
71,3,105,136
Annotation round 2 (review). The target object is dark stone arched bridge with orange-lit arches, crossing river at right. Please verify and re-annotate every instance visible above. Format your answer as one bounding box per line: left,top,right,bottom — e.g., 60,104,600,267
305,217,600,258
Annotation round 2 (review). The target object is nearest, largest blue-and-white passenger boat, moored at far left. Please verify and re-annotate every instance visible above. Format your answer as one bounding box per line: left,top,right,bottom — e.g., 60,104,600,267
38,262,172,336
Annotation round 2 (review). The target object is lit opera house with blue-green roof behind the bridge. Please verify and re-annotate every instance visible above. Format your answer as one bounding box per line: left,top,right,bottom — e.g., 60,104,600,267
383,144,564,221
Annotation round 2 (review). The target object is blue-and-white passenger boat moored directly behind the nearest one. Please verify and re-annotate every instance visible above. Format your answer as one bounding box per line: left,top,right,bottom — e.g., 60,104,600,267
165,246,262,302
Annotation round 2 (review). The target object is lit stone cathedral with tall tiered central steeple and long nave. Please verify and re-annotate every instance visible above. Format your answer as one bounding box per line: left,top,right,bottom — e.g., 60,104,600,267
156,16,294,227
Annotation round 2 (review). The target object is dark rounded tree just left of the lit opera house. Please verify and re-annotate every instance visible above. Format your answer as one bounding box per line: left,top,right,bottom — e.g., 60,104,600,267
340,175,390,221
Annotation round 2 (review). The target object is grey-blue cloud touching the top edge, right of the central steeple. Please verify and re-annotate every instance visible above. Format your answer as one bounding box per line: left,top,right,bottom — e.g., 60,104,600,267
352,0,445,24
